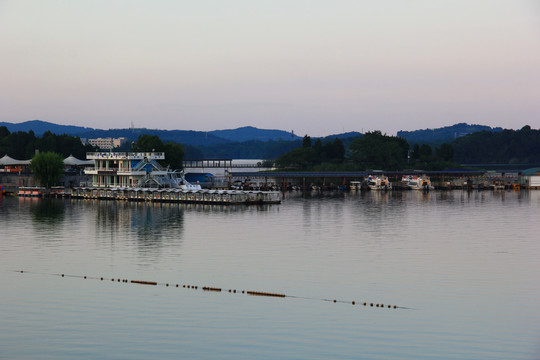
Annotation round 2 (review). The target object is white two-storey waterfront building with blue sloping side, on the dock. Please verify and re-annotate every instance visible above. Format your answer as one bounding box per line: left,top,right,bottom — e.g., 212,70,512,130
85,152,179,188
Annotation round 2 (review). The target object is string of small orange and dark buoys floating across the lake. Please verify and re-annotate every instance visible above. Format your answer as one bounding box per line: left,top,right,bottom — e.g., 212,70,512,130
15,270,411,310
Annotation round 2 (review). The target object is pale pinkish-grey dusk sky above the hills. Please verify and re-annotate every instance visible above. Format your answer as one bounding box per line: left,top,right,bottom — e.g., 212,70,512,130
0,0,540,136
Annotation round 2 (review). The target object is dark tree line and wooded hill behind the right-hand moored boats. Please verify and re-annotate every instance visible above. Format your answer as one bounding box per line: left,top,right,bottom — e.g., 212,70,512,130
275,125,540,170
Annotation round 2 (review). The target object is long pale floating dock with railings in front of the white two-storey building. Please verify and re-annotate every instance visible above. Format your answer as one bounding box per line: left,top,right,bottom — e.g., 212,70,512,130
71,188,281,205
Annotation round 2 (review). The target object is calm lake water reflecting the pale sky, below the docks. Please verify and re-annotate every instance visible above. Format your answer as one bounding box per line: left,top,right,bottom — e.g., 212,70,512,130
0,191,540,360
